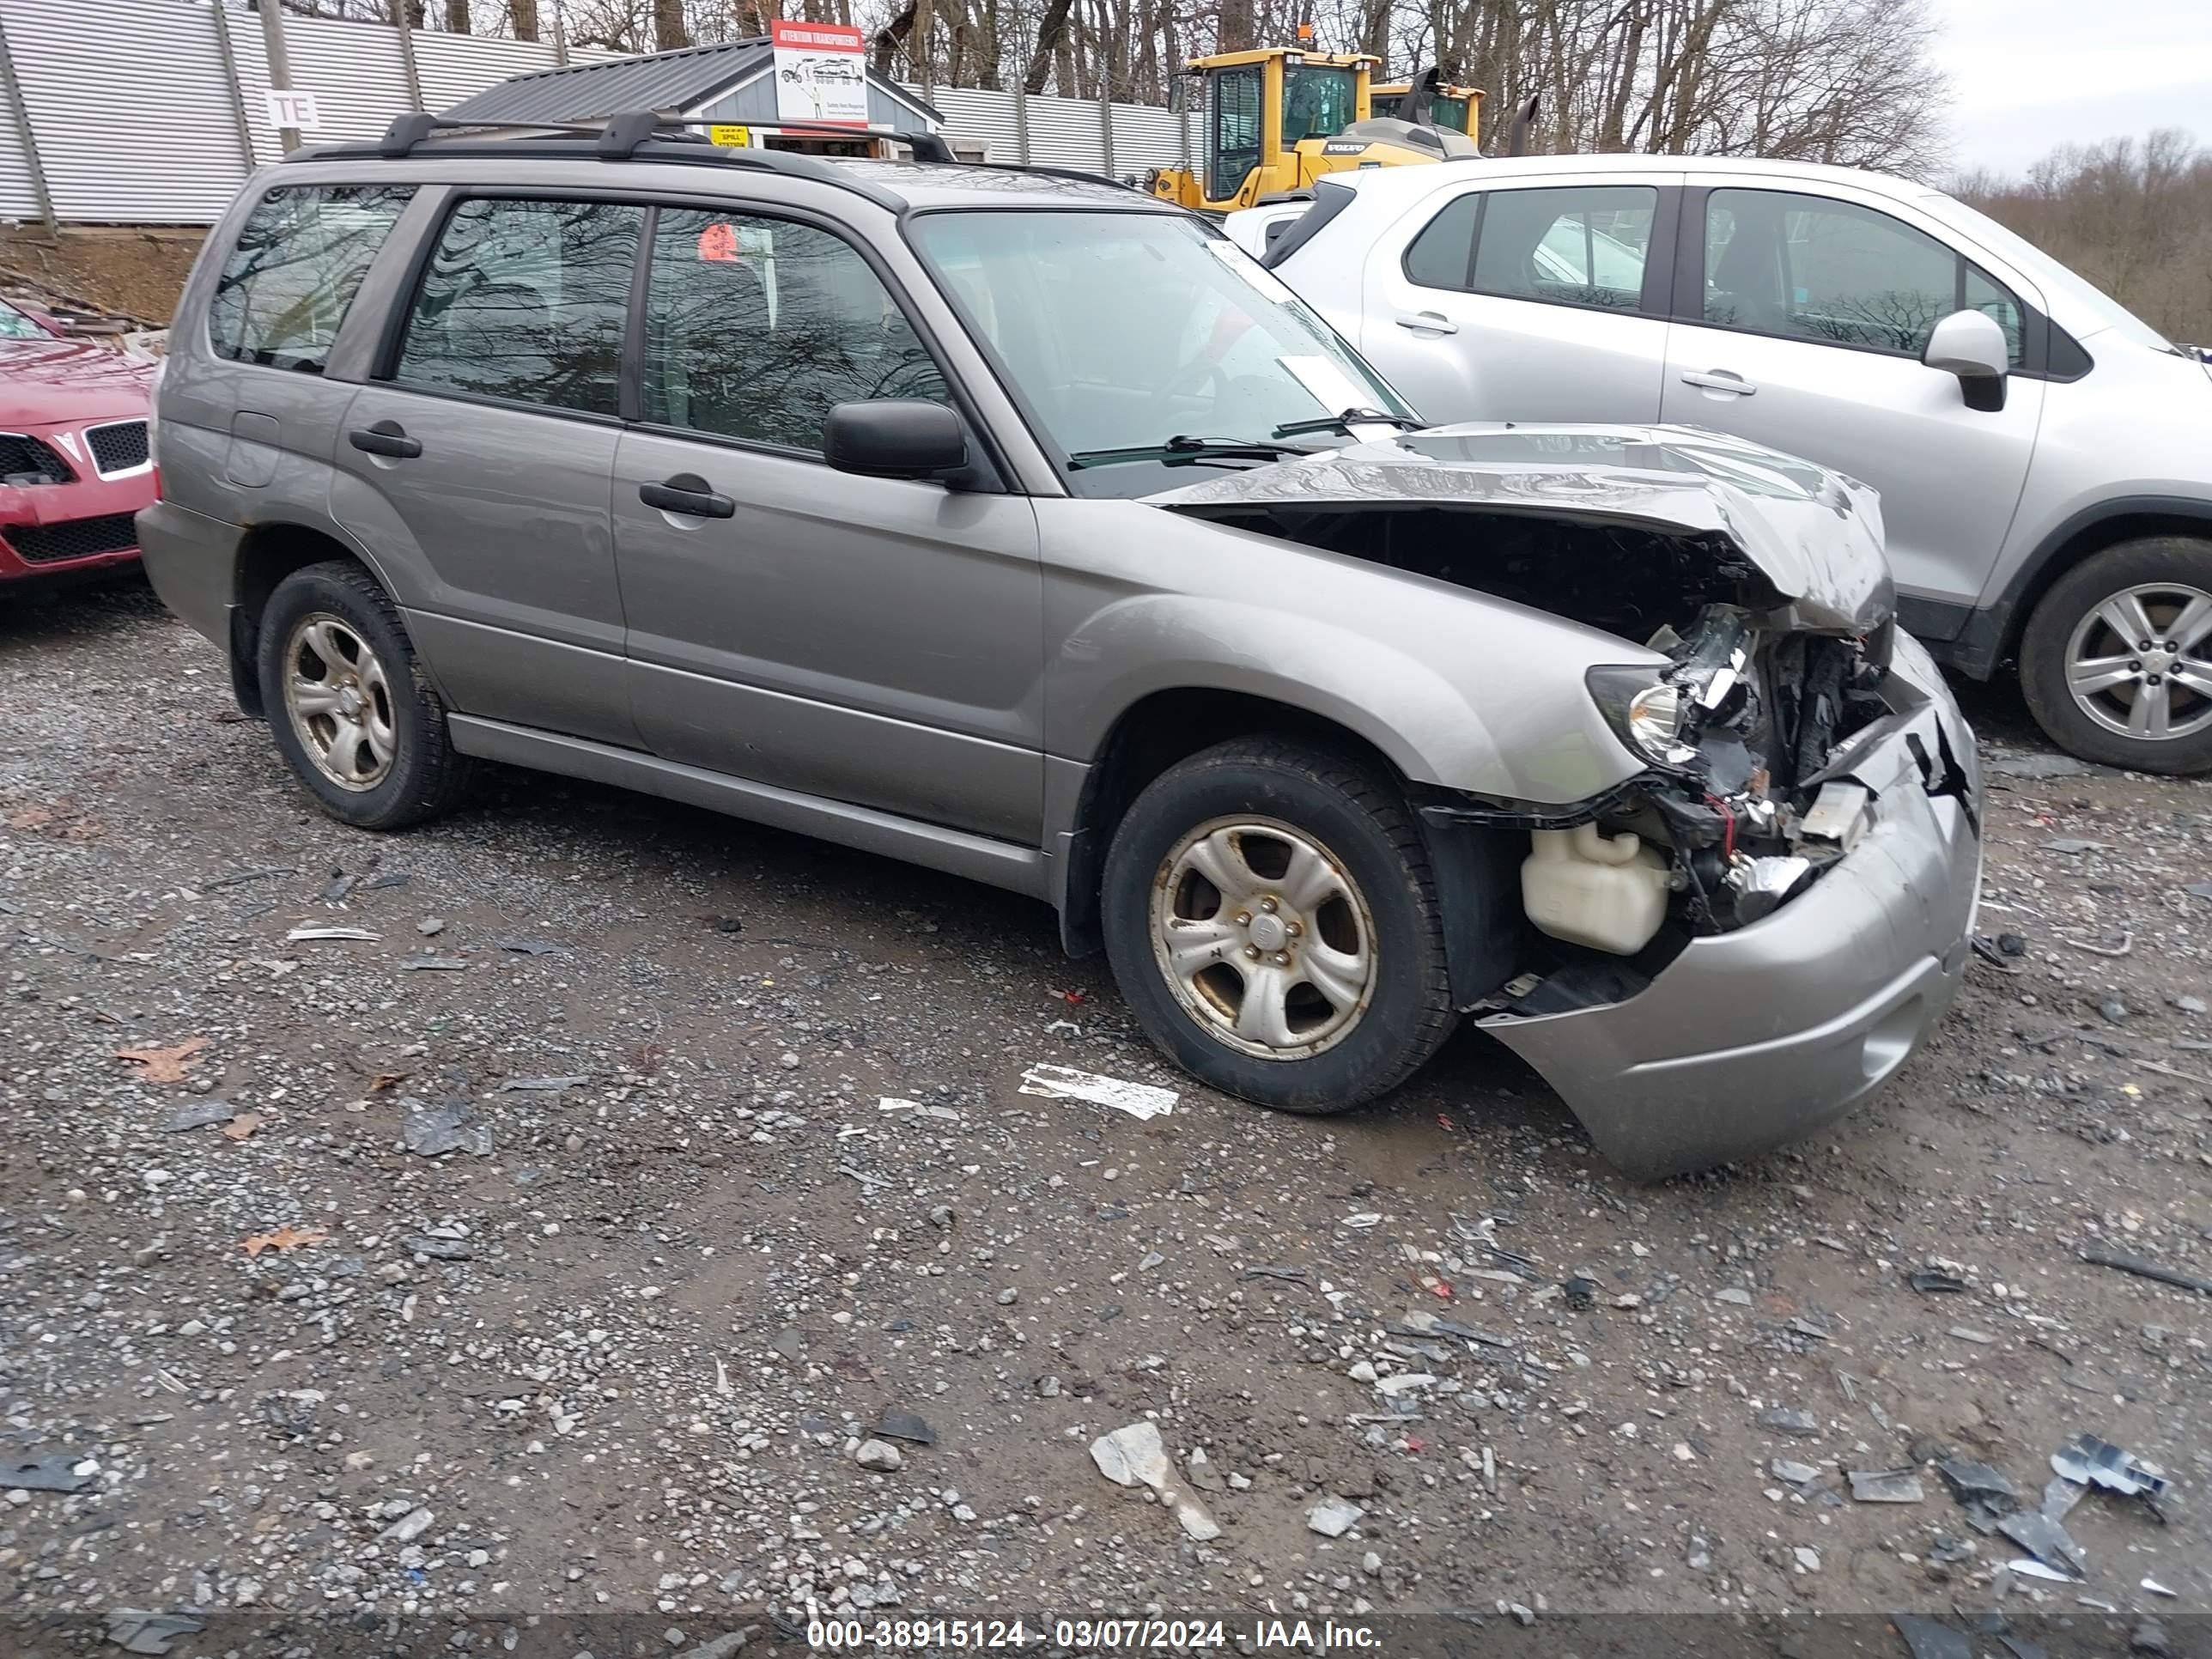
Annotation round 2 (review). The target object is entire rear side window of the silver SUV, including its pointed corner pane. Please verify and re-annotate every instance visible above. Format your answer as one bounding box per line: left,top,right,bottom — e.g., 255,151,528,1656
1405,184,1659,312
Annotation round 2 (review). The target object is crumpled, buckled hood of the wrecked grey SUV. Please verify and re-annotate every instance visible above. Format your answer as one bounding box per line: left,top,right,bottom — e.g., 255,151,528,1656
1146,420,1896,633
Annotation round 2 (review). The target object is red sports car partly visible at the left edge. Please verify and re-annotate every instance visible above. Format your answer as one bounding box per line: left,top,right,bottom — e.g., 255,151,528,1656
0,301,159,584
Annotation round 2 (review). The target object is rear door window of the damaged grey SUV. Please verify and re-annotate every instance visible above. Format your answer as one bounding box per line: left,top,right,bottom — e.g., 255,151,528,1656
398,197,646,416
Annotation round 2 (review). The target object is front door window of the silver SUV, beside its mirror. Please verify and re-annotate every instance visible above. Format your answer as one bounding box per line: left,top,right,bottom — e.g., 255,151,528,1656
1705,191,2021,368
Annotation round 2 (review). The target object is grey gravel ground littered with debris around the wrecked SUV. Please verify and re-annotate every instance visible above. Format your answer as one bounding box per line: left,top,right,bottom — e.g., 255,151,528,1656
0,586,2212,1659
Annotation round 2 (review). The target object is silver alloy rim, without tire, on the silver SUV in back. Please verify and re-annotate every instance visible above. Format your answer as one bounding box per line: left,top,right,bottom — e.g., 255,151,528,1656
2066,581,2212,741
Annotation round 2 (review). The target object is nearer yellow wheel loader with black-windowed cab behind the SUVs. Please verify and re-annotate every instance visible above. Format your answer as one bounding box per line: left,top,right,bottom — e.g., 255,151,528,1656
1148,46,1480,212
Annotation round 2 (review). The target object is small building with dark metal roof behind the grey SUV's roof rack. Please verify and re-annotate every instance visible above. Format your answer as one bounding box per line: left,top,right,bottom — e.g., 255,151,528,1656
441,38,945,137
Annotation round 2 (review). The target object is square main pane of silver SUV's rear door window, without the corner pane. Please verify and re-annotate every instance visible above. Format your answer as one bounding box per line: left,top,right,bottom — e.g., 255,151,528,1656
1467,184,1659,312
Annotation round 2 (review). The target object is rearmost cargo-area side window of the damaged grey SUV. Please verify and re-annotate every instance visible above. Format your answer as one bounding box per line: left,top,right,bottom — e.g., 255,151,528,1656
208,184,414,374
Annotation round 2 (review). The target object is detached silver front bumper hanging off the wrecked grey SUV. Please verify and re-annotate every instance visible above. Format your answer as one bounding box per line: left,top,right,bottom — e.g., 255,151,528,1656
1482,635,1982,1179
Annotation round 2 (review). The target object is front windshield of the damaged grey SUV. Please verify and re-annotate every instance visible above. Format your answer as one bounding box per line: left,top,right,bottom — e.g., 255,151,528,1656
911,210,1409,495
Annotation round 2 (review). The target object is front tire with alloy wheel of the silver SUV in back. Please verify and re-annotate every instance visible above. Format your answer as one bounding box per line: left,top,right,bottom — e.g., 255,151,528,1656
2020,535,2212,772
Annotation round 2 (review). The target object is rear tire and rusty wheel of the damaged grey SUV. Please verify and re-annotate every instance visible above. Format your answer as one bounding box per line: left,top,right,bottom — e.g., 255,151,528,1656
254,560,473,830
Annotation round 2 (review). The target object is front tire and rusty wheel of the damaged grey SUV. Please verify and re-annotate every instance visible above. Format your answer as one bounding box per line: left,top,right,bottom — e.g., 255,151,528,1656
1099,738,1458,1113
